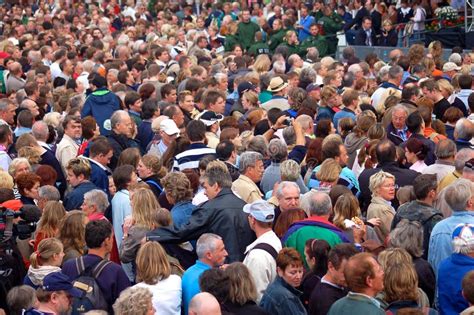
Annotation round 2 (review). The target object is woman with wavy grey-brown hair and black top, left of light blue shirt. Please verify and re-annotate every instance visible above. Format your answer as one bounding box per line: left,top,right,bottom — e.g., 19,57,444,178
389,219,436,305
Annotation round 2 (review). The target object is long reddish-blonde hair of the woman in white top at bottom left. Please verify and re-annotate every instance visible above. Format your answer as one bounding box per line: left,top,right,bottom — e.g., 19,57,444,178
136,242,171,285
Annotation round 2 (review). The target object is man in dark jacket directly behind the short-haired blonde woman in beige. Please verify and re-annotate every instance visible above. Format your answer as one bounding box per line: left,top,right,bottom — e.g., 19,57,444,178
359,140,419,211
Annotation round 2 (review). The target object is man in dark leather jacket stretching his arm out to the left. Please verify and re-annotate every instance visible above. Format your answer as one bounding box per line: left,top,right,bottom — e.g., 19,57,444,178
147,161,255,262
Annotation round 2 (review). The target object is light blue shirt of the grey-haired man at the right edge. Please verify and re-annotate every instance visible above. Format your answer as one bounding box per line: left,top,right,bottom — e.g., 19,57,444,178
428,211,474,276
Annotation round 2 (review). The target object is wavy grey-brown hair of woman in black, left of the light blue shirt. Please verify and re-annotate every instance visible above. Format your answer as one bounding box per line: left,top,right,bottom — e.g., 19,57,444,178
389,219,423,257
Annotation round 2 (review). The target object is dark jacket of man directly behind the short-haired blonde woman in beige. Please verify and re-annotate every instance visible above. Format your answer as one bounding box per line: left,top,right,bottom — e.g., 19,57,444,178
359,162,419,211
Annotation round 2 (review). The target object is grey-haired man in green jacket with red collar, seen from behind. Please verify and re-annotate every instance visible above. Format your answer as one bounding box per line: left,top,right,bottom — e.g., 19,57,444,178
282,190,349,268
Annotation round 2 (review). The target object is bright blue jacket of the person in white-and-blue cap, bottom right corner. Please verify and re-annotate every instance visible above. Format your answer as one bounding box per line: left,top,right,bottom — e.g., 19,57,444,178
437,254,474,315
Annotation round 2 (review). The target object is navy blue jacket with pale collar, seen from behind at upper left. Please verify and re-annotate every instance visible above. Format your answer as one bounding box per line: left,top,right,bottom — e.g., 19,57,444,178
81,88,120,135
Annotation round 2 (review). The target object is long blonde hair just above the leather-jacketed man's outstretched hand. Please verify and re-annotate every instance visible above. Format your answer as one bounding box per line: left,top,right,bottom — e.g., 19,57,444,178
132,188,160,229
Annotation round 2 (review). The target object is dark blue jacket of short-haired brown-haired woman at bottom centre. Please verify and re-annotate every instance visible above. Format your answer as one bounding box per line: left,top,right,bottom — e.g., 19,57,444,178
260,276,308,315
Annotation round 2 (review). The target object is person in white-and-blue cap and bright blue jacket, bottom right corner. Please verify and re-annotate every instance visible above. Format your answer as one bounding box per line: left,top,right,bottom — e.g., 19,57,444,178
437,223,474,314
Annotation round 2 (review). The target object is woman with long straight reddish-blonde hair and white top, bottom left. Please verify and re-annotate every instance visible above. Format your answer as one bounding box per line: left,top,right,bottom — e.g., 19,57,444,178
133,242,182,315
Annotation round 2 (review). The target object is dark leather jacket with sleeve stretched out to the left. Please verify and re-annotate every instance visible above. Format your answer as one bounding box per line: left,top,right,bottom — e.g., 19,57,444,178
147,188,255,263
